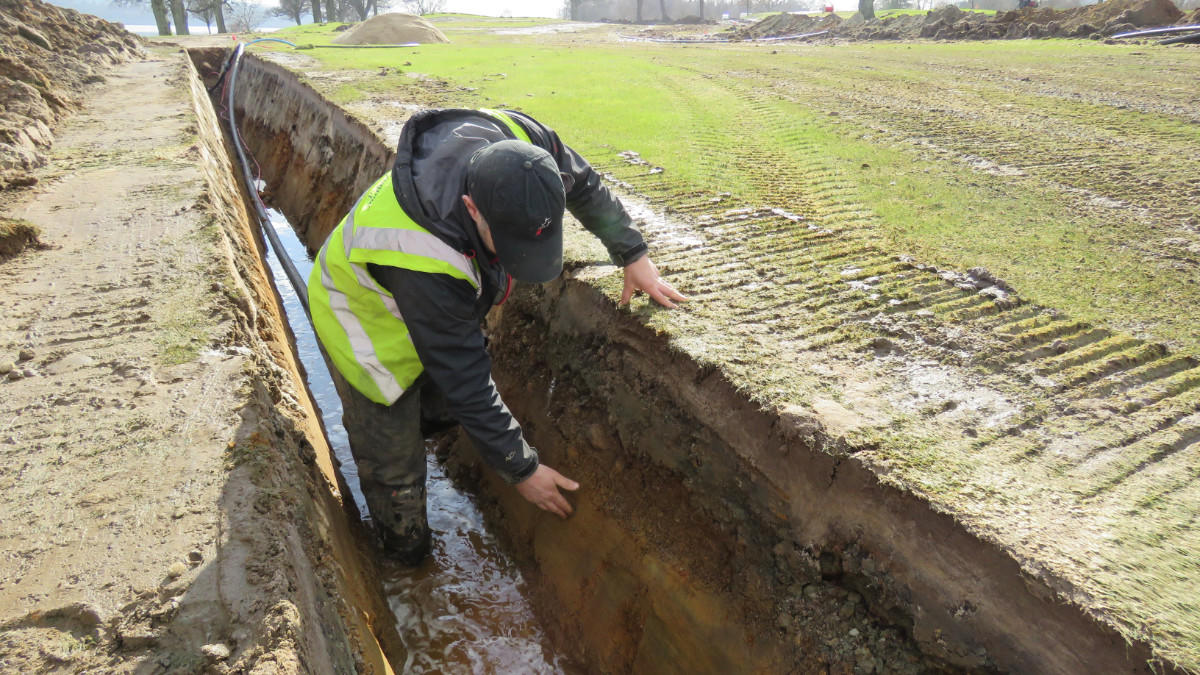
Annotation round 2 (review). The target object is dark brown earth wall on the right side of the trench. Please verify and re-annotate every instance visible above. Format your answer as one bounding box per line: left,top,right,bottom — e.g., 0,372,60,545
211,52,1176,673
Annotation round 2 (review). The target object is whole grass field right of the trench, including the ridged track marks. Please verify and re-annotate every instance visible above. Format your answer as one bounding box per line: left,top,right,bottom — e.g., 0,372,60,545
262,19,1200,669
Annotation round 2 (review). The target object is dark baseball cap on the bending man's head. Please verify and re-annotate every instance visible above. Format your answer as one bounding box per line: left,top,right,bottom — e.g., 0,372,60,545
467,141,566,283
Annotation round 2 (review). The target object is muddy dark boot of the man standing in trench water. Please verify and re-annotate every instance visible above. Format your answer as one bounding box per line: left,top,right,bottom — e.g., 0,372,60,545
362,477,432,567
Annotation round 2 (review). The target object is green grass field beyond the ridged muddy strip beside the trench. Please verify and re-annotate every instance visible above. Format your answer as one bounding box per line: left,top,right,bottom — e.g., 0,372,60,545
270,16,1200,351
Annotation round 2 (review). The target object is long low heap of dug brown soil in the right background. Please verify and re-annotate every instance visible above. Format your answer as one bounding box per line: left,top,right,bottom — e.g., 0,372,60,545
731,0,1195,40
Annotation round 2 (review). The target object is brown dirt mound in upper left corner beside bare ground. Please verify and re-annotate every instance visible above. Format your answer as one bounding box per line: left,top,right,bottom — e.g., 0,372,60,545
0,0,140,190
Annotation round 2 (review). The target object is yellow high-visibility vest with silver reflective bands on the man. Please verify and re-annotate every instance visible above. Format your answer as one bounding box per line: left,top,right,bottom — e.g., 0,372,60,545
308,109,529,405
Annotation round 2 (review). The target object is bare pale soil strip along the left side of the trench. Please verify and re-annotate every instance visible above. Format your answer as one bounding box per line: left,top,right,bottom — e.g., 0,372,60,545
0,49,402,673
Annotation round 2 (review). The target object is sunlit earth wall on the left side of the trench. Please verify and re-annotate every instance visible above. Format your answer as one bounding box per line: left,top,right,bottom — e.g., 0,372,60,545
181,51,404,674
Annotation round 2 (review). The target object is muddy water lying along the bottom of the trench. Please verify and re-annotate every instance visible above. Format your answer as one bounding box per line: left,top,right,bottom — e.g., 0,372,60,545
262,211,575,674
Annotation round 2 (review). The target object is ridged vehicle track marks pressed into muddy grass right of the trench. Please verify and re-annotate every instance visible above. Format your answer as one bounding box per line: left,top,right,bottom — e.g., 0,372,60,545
580,55,1200,665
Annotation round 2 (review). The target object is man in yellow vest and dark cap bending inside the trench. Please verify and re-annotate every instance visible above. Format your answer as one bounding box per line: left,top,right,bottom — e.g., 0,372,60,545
308,109,685,565
